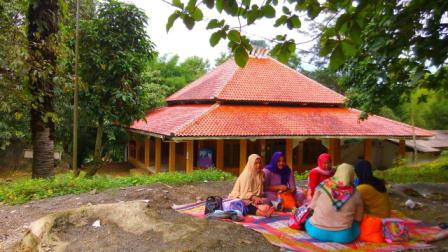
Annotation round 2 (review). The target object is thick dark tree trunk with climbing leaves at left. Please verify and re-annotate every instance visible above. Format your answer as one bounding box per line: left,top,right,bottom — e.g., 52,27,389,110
27,0,61,178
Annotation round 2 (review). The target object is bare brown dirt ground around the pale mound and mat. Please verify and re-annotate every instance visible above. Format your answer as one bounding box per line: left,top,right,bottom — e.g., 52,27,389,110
0,181,448,251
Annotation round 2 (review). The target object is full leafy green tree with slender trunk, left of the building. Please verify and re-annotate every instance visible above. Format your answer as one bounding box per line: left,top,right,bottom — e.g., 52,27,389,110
80,0,156,169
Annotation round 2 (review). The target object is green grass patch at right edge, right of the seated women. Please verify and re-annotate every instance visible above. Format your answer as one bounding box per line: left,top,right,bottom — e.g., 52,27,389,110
375,153,448,183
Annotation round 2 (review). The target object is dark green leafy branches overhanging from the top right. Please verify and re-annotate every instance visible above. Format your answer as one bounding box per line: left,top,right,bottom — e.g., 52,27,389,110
167,0,448,114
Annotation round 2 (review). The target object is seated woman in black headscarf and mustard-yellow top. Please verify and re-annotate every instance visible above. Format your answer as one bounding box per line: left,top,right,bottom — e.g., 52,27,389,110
355,160,391,218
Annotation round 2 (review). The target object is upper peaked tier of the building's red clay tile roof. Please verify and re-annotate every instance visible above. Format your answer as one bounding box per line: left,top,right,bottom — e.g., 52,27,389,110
167,57,345,105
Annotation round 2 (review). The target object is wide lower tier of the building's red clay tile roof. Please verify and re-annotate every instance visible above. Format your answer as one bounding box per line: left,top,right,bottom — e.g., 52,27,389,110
131,105,432,138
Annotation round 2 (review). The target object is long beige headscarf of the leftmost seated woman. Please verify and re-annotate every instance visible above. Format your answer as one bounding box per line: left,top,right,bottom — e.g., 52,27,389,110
229,154,264,200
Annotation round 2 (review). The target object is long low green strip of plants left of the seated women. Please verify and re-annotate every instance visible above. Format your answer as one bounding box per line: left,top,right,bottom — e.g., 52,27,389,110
0,169,233,205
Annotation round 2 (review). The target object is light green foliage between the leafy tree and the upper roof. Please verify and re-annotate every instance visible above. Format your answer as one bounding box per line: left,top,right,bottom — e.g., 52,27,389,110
146,55,210,95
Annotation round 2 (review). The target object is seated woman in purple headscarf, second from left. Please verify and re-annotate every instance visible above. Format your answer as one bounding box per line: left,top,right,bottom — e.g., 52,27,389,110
263,151,304,207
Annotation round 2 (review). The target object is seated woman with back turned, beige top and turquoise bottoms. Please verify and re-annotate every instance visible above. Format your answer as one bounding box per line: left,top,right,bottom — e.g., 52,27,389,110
305,164,363,243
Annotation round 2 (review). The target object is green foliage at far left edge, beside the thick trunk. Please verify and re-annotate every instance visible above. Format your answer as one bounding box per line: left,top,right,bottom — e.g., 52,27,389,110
0,0,31,150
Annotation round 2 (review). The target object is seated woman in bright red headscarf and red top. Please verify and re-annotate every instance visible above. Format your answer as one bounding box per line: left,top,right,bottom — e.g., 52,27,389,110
307,153,335,201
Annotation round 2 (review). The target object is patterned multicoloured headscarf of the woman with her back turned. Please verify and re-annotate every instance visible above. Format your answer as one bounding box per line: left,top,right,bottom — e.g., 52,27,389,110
317,163,355,211
